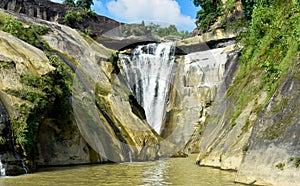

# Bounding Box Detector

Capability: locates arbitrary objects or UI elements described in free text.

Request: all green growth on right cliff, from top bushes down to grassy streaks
[227,1,300,128]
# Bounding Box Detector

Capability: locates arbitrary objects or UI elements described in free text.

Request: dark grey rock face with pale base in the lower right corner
[236,73,300,185]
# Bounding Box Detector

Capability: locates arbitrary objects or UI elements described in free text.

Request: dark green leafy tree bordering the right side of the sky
[194,0,222,32]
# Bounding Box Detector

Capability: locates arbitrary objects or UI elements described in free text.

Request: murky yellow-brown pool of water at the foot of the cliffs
[0,155,238,186]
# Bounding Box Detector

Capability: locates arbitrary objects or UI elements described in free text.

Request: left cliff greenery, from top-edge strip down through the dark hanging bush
[0,14,72,163]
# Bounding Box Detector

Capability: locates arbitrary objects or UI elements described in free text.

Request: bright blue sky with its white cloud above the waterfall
[51,0,199,31]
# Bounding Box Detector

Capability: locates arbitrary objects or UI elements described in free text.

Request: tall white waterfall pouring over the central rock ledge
[119,43,175,134]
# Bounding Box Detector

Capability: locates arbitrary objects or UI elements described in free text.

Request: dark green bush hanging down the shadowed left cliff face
[7,55,72,158]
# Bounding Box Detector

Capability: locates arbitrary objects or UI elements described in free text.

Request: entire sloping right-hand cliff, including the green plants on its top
[197,2,300,185]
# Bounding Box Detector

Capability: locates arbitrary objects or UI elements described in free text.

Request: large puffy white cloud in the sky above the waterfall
[106,0,195,30]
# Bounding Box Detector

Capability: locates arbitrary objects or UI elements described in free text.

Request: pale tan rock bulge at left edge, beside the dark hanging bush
[0,31,54,175]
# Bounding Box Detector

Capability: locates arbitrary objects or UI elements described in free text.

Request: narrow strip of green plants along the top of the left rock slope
[0,15,50,47]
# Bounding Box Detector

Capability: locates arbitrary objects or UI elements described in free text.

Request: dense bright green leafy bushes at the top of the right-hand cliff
[241,3,300,91]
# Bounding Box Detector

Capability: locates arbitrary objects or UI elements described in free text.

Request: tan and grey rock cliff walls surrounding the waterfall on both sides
[0,0,300,185]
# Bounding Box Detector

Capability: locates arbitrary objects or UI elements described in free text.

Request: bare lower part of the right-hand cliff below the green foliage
[193,29,300,185]
